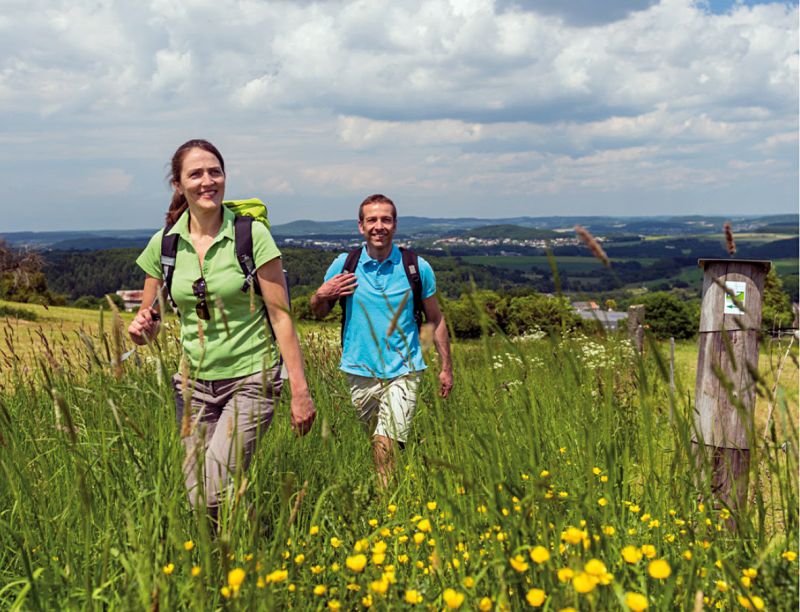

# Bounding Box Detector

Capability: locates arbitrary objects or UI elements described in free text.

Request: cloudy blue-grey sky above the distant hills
[0,0,799,232]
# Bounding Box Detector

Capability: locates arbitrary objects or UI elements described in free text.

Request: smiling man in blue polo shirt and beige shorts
[311,194,453,486]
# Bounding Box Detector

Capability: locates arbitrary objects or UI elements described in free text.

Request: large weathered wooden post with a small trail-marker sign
[692,259,771,510]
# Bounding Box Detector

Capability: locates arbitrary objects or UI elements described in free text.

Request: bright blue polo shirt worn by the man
[325,245,436,378]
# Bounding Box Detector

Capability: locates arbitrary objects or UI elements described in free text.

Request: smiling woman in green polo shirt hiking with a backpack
[128,140,316,520]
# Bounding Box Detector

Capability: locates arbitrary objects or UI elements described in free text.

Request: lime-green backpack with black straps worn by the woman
[161,198,289,316]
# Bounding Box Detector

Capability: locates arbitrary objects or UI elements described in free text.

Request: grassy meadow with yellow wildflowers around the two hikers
[0,307,799,610]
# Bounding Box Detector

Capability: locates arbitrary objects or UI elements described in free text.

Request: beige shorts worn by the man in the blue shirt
[347,372,422,442]
